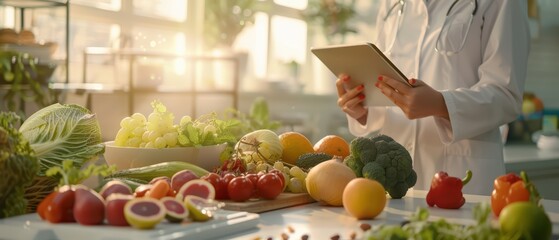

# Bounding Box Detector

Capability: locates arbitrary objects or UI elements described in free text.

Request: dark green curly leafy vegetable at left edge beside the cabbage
[0,112,39,218]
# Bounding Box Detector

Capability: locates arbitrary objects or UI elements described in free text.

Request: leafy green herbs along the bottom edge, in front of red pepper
[364,203,505,240]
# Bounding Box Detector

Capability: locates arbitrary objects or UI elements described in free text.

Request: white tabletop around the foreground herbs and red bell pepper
[227,190,559,240]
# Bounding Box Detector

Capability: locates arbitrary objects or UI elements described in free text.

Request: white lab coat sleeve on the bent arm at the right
[435,0,530,143]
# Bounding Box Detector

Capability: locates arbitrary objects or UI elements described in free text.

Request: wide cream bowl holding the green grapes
[103,141,227,171]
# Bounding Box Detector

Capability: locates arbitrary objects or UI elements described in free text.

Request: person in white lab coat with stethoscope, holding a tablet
[336,0,530,195]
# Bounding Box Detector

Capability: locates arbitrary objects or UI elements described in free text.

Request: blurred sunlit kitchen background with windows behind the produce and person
[0,0,559,238]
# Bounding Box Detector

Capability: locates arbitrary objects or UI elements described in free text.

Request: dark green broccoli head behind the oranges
[348,135,417,198]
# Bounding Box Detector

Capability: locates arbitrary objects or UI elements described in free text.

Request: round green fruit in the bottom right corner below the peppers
[499,202,552,239]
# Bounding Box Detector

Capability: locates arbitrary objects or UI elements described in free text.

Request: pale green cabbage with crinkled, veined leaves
[19,103,105,176]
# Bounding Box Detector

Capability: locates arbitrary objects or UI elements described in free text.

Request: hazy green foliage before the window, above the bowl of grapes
[204,0,258,49]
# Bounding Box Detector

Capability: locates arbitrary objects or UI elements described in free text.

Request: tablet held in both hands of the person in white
[311,43,411,106]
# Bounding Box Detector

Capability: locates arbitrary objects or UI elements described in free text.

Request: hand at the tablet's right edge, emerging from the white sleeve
[375,76,449,119]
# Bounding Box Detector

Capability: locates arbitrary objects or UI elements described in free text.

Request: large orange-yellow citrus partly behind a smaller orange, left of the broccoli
[306,158,356,206]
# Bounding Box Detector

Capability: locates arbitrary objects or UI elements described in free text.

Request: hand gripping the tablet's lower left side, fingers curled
[336,75,368,124]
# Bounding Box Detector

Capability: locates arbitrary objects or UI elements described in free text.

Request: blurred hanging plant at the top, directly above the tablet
[303,0,357,44]
